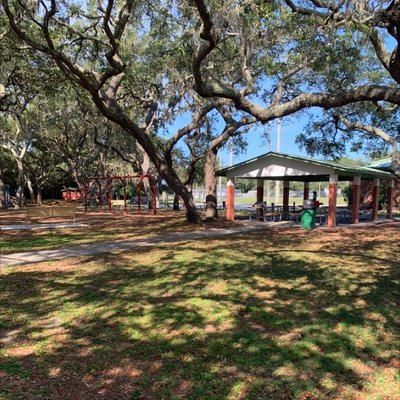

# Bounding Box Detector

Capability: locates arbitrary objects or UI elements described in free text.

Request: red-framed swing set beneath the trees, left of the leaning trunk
[85,174,157,214]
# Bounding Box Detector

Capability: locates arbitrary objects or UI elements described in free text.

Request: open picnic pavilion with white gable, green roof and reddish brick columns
[216,151,397,228]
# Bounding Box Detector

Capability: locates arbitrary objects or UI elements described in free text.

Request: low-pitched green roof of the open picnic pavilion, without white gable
[216,151,394,181]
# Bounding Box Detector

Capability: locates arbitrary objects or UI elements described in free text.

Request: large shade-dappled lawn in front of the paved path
[0,223,400,400]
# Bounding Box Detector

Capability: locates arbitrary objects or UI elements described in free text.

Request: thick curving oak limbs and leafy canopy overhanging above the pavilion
[193,0,400,175]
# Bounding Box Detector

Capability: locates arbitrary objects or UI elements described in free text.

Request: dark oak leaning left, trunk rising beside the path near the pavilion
[2,0,212,222]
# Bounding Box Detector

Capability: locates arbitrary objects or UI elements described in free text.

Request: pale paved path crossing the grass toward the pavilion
[0,221,290,268]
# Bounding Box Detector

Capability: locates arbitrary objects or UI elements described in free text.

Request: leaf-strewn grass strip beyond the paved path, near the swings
[0,210,230,254]
